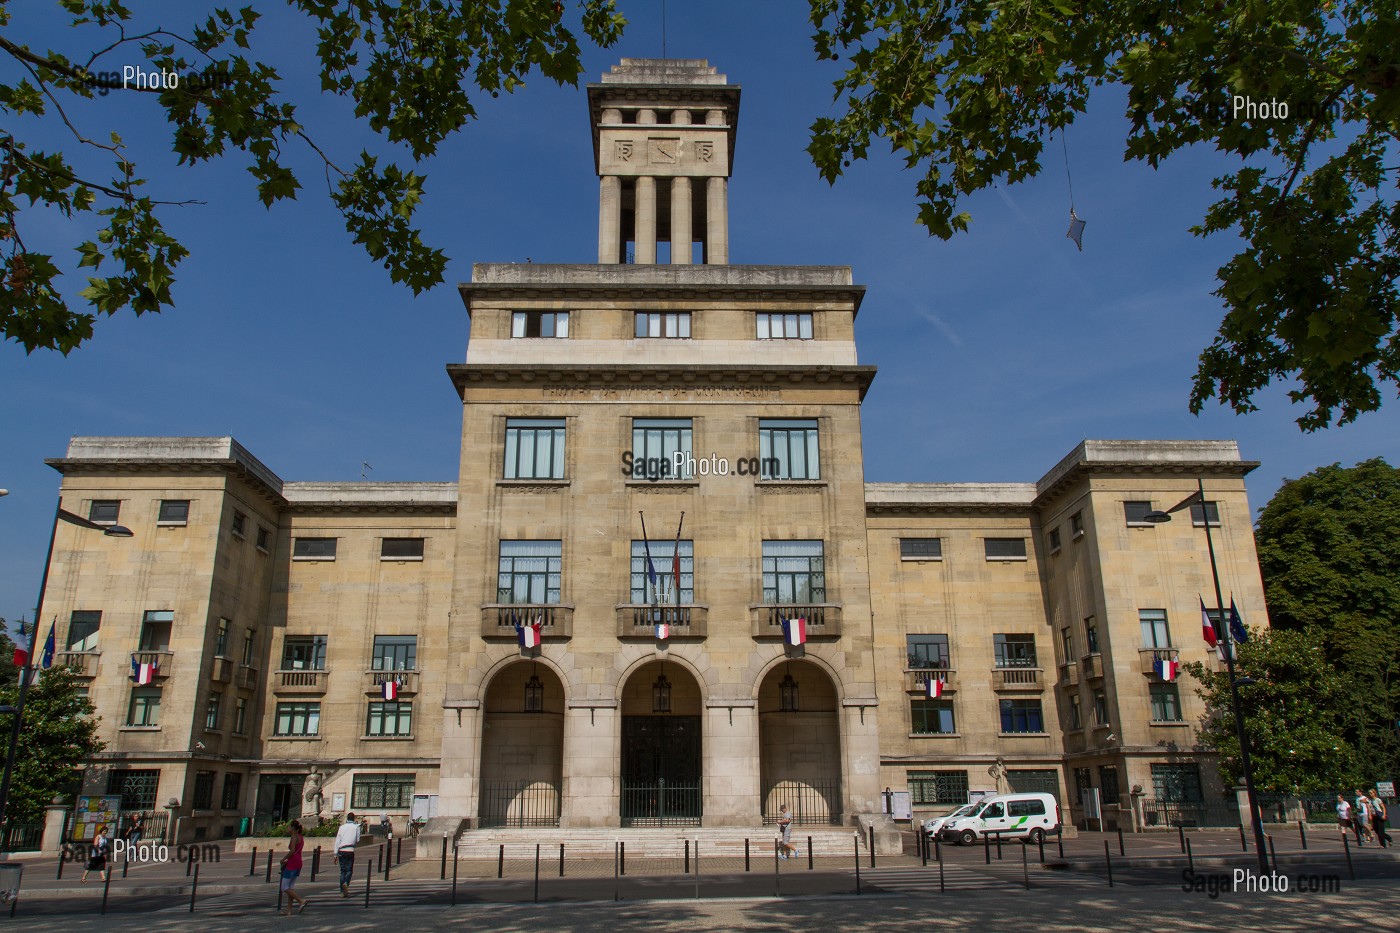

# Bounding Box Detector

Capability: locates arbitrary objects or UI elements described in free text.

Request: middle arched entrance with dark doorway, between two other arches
[619,661,703,827]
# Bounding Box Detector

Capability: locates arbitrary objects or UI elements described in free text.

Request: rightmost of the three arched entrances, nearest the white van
[759,660,841,825]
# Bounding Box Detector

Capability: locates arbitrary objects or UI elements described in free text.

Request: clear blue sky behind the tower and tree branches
[0,0,1400,619]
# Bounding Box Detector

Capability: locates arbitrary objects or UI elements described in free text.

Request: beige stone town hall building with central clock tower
[35,60,1264,839]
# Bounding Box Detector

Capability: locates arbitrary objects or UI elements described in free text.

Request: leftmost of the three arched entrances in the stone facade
[479,660,564,827]
